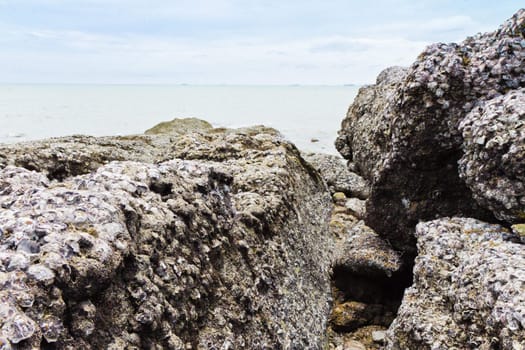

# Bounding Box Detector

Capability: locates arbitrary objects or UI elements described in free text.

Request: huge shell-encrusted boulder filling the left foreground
[0,128,333,349]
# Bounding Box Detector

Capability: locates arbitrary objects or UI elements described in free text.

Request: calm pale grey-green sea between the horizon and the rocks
[0,85,358,153]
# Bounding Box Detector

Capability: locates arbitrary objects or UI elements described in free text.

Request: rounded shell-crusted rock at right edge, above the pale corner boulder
[459,89,525,223]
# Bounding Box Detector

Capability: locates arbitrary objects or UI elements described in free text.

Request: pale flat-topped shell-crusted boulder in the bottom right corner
[386,218,525,349]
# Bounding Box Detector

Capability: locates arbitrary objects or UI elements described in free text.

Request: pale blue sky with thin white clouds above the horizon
[0,0,523,85]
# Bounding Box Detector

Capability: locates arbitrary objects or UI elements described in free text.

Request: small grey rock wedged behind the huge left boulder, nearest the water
[302,153,370,199]
